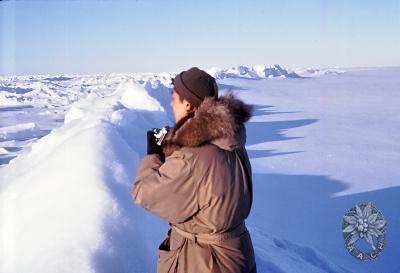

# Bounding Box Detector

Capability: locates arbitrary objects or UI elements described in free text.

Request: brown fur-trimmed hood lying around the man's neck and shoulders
[163,93,253,155]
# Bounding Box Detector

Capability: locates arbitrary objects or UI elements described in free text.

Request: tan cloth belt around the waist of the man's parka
[172,222,247,244]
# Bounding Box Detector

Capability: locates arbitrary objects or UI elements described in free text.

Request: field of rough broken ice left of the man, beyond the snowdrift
[0,72,176,108]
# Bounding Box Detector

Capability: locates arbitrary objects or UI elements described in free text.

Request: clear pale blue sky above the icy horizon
[0,0,400,75]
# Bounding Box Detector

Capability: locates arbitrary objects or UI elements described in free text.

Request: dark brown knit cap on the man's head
[172,67,218,107]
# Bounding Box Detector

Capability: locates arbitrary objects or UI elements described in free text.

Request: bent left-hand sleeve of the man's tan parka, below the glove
[132,151,198,223]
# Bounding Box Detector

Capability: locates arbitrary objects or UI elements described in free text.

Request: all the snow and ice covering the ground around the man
[0,66,400,273]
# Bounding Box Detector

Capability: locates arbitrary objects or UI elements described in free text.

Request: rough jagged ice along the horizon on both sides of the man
[0,64,344,108]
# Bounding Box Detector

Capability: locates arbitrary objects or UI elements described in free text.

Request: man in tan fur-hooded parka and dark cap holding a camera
[132,67,256,273]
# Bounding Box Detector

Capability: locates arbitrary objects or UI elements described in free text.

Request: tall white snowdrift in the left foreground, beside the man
[0,82,167,272]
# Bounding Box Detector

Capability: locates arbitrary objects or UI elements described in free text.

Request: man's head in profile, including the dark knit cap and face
[171,67,218,121]
